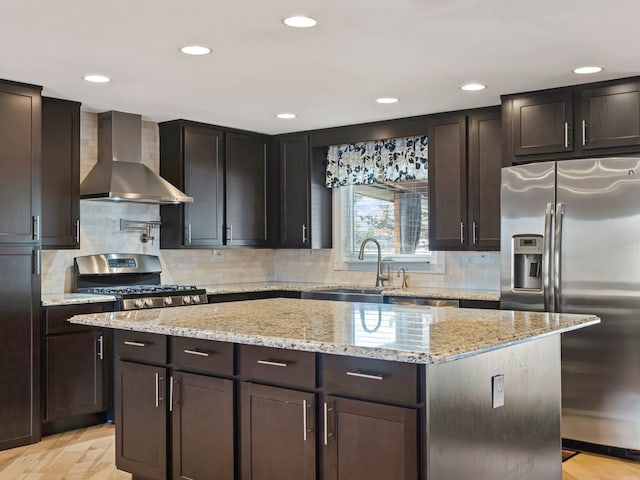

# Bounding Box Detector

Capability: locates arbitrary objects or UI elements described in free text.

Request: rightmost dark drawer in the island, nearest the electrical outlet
[322,355,418,404]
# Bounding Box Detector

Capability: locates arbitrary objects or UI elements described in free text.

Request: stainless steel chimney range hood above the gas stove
[80,111,193,204]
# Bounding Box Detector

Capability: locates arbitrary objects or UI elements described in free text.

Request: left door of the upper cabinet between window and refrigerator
[429,115,467,250]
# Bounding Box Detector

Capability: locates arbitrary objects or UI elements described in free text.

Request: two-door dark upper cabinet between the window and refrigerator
[429,107,502,250]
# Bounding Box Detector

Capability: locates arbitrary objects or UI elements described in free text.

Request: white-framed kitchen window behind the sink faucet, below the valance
[336,180,437,269]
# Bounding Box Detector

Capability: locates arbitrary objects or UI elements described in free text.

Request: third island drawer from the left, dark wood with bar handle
[239,345,316,388]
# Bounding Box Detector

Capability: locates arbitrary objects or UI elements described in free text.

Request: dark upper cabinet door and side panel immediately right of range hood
[159,121,224,248]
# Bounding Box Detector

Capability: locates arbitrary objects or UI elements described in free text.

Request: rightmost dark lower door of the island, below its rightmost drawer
[322,396,419,480]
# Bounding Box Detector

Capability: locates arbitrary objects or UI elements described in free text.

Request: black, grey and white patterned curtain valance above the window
[326,136,428,188]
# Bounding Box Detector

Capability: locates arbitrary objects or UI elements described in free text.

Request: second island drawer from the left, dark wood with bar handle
[171,337,233,375]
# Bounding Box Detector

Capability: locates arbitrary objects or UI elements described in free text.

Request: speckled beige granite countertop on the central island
[70,298,600,363]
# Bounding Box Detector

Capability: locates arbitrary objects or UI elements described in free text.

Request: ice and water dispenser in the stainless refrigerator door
[512,235,542,290]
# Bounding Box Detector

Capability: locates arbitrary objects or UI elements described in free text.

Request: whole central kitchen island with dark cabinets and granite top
[70,299,599,480]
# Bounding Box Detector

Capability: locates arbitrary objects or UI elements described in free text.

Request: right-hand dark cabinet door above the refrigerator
[580,82,640,150]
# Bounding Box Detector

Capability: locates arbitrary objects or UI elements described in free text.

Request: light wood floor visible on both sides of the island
[0,425,640,480]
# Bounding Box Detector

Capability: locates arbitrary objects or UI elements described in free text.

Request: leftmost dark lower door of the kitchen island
[115,360,167,480]
